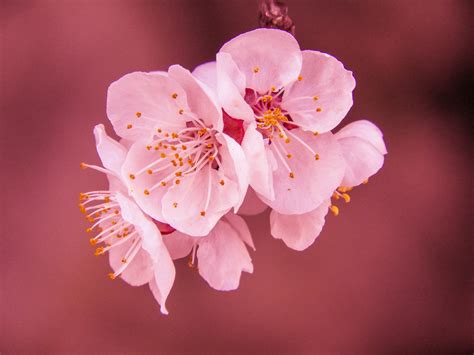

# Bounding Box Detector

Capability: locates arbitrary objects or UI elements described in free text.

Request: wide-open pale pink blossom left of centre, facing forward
[107,65,249,236]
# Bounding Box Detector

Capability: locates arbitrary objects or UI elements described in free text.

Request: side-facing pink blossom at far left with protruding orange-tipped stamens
[79,125,175,314]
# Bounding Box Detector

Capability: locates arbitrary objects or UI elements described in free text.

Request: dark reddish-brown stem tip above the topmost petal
[258,0,295,36]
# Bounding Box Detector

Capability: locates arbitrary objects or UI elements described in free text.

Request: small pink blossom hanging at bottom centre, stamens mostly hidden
[164,212,255,291]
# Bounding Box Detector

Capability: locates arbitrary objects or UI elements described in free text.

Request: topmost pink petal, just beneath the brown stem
[220,29,302,94]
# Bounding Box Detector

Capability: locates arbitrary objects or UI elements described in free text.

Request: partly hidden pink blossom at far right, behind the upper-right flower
[270,121,387,250]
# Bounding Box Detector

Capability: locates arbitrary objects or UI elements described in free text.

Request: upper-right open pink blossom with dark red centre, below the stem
[194,29,355,214]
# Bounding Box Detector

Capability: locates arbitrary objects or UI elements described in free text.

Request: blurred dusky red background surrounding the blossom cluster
[0,0,473,354]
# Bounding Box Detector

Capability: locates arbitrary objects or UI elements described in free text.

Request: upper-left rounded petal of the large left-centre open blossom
[107,72,189,141]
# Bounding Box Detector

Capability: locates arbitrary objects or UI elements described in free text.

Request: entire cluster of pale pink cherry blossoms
[79,29,387,314]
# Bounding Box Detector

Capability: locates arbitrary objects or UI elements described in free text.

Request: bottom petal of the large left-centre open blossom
[162,167,239,237]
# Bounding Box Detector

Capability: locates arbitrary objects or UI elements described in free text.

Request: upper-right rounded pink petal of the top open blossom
[282,51,355,133]
